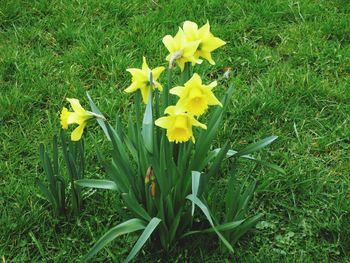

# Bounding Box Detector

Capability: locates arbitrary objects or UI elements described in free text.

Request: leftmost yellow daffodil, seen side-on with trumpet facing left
[60,99,94,141]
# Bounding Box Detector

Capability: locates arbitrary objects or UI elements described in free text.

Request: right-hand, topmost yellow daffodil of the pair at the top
[183,21,226,65]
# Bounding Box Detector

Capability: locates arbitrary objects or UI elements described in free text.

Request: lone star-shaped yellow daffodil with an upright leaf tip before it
[124,57,165,103]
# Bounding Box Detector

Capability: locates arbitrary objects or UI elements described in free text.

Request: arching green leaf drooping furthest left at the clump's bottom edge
[84,218,146,261]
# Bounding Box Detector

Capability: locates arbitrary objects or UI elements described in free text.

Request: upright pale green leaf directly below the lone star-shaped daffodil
[142,87,153,153]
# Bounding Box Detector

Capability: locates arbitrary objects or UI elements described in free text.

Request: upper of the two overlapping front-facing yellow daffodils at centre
[170,73,222,116]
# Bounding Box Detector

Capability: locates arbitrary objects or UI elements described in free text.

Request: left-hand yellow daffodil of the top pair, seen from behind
[163,28,200,71]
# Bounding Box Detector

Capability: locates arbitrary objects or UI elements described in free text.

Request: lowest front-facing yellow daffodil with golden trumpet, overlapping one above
[155,106,207,143]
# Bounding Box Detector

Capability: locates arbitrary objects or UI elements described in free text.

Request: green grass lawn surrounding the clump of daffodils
[0,0,350,262]
